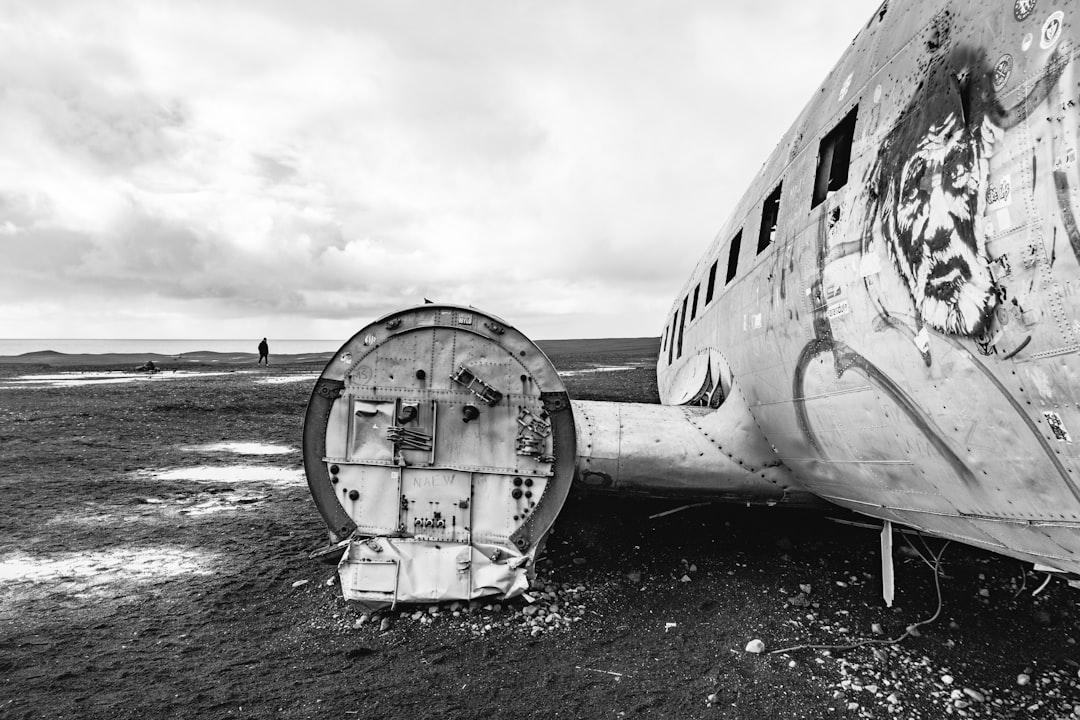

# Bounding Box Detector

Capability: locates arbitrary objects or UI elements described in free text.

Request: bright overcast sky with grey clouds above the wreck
[0,0,879,340]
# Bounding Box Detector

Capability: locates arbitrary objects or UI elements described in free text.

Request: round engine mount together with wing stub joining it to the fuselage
[303,304,809,604]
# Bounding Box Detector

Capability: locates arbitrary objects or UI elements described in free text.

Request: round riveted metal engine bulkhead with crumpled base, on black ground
[303,304,576,603]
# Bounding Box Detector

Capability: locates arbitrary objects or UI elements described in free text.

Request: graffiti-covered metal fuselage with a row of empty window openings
[657,0,1080,572]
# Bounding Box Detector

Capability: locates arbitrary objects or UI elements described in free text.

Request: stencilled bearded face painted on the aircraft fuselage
[881,113,995,336]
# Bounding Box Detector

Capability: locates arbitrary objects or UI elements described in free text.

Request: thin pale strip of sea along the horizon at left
[0,338,349,356]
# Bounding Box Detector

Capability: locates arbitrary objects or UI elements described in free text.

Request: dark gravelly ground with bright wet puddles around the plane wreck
[0,340,1080,720]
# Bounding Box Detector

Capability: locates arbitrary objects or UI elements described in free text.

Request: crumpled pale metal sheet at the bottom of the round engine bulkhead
[338,538,536,607]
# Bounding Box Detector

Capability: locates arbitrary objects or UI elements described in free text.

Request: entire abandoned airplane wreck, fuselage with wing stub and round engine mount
[303,0,1080,604]
